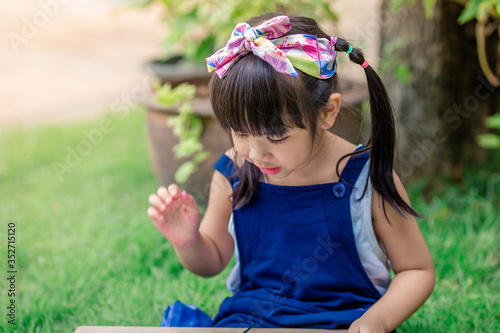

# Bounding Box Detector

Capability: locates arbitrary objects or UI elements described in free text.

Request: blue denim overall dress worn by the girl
[162,148,381,329]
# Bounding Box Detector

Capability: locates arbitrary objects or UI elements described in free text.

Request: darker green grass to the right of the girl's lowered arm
[399,167,500,332]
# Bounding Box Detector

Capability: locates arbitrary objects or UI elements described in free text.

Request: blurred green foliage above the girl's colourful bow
[135,0,337,65]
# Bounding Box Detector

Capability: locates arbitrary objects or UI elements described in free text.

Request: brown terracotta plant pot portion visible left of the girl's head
[143,63,231,204]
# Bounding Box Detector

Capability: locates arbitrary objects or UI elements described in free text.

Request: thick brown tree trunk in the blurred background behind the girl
[381,0,500,179]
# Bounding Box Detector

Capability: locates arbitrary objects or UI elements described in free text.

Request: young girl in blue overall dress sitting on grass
[148,13,435,332]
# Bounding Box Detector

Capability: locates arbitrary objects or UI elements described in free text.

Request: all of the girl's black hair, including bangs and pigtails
[209,13,420,217]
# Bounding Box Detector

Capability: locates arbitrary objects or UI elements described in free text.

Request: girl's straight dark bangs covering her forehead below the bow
[210,54,308,137]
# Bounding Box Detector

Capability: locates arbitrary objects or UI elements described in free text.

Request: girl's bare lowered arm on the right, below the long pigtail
[348,173,435,333]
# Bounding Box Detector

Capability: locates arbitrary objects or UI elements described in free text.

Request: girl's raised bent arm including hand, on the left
[148,167,234,277]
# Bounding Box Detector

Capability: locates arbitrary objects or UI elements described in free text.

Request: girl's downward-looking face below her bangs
[231,128,313,180]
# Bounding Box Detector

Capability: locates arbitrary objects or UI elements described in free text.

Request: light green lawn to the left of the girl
[0,111,228,332]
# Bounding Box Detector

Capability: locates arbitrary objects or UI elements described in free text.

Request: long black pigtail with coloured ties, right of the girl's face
[335,37,422,217]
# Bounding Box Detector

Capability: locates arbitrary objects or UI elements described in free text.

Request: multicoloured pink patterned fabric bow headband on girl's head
[206,16,337,79]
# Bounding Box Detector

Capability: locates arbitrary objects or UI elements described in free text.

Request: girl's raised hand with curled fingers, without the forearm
[148,184,200,246]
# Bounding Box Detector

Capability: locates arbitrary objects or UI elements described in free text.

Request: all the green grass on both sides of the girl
[0,110,500,332]
